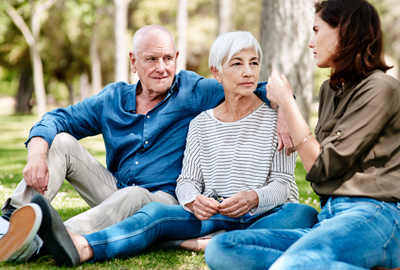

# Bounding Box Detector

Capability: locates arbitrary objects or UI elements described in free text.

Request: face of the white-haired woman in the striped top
[211,49,260,96]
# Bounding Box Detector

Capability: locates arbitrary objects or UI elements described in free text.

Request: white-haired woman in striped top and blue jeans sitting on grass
[0,32,317,266]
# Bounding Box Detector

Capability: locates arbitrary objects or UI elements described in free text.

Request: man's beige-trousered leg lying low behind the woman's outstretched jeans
[64,186,178,234]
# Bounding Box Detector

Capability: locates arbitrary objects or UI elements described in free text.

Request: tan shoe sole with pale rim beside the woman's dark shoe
[0,204,42,262]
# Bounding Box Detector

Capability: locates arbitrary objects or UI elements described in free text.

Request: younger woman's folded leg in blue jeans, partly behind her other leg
[205,229,310,270]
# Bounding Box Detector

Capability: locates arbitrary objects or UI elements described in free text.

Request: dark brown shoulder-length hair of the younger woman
[314,0,392,90]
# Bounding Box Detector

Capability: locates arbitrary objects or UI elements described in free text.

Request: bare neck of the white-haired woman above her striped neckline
[214,92,262,122]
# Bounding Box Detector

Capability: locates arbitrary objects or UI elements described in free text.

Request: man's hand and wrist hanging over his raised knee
[23,137,50,195]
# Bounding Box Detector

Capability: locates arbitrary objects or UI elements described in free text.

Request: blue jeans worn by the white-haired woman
[84,202,318,261]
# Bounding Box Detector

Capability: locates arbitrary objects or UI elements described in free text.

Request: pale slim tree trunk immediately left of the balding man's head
[114,0,131,82]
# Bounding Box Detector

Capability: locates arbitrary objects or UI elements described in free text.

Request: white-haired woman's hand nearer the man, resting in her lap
[185,195,219,220]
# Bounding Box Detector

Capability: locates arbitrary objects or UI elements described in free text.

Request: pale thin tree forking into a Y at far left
[7,0,58,117]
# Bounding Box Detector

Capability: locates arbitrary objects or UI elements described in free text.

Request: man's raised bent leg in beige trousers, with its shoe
[2,133,118,213]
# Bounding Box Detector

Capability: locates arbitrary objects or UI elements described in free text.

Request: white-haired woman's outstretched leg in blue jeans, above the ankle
[84,202,223,261]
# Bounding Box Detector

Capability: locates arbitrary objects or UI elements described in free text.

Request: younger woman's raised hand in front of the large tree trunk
[267,69,293,106]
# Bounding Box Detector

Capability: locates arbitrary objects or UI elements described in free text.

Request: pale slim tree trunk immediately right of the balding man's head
[176,0,188,72]
